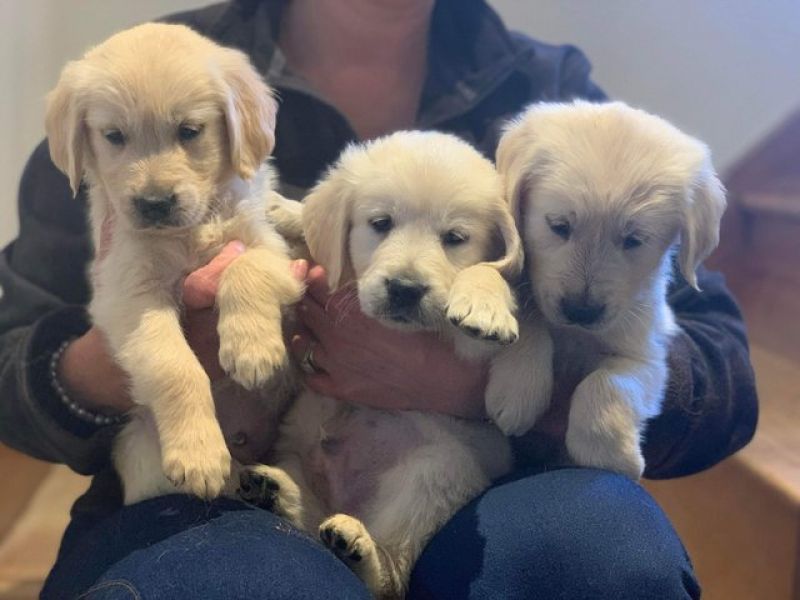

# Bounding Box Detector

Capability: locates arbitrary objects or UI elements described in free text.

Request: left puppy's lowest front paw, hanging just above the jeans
[161,420,231,500]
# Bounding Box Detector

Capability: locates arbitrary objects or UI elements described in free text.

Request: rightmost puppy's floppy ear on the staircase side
[678,155,726,290]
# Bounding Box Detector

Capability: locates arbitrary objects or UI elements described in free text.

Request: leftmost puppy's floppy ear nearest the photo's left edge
[45,62,88,196]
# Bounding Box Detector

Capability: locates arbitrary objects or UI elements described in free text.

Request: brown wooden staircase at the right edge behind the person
[646,112,800,600]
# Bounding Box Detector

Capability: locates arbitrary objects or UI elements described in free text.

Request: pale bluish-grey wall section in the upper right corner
[493,0,800,170]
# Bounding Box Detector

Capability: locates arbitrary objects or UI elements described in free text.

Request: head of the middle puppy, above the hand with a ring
[303,131,522,329]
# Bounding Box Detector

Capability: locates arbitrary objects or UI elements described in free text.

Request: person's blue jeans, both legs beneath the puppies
[42,469,700,600]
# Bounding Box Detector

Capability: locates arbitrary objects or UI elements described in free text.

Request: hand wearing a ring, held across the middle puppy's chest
[291,266,488,419]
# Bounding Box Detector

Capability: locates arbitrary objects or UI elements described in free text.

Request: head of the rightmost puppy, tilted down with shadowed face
[504,102,725,330]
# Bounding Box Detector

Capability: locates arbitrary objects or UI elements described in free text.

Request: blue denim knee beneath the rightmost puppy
[411,469,700,600]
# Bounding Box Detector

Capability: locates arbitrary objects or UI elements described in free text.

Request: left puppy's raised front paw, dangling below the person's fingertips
[218,314,287,390]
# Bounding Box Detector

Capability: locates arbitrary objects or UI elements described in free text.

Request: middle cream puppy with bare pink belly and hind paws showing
[241,132,536,597]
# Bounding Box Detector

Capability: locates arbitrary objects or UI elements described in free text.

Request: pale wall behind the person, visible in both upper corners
[0,0,800,245]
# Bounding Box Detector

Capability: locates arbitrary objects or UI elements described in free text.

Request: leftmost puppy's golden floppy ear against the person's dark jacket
[221,49,278,179]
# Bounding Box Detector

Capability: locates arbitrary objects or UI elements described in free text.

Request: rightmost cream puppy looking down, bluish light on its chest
[497,102,725,478]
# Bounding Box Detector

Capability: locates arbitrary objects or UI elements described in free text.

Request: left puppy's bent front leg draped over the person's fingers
[217,247,302,389]
